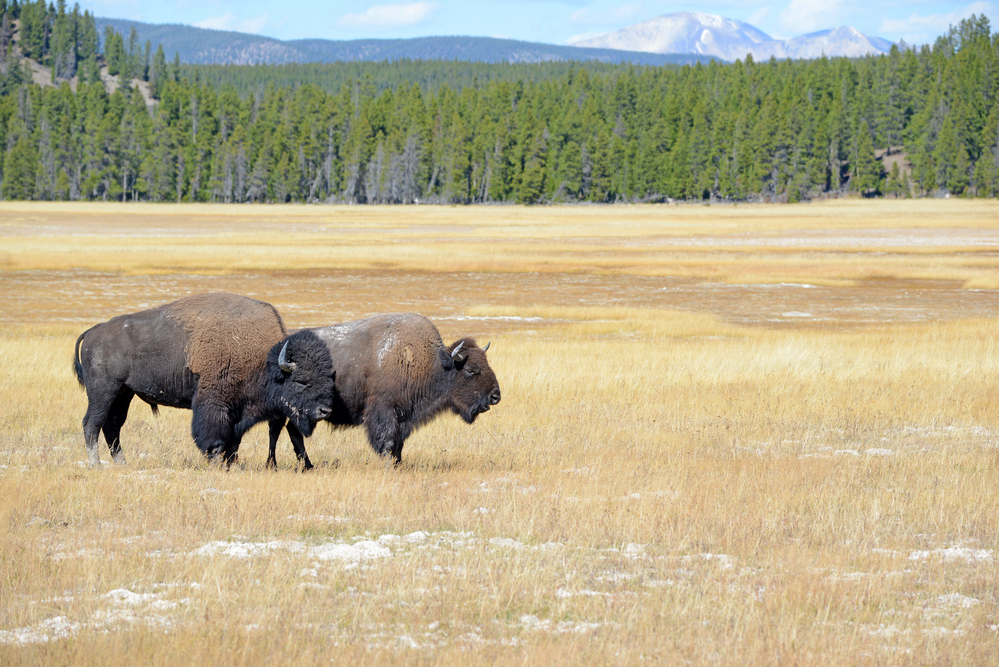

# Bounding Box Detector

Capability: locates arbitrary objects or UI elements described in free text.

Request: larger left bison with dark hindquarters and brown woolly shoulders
[73,294,335,468]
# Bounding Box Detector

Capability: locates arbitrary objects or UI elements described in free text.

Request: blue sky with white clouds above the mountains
[80,0,999,44]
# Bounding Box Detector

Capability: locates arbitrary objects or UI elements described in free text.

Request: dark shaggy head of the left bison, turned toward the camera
[267,331,336,436]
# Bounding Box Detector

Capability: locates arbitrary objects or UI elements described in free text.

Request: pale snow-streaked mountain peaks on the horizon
[576,12,891,60]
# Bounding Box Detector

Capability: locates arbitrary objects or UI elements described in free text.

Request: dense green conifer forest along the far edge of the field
[0,16,999,203]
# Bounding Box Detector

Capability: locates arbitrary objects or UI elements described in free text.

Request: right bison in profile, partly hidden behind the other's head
[267,313,500,466]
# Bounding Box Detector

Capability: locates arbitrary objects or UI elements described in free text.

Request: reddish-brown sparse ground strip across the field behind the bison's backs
[0,270,999,335]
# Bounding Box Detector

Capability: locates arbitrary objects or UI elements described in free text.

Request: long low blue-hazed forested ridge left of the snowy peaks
[95,18,715,65]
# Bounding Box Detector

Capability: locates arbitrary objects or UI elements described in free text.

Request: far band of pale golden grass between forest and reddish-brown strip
[0,200,999,288]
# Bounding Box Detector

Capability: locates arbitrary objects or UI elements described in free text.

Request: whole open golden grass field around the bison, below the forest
[0,200,999,665]
